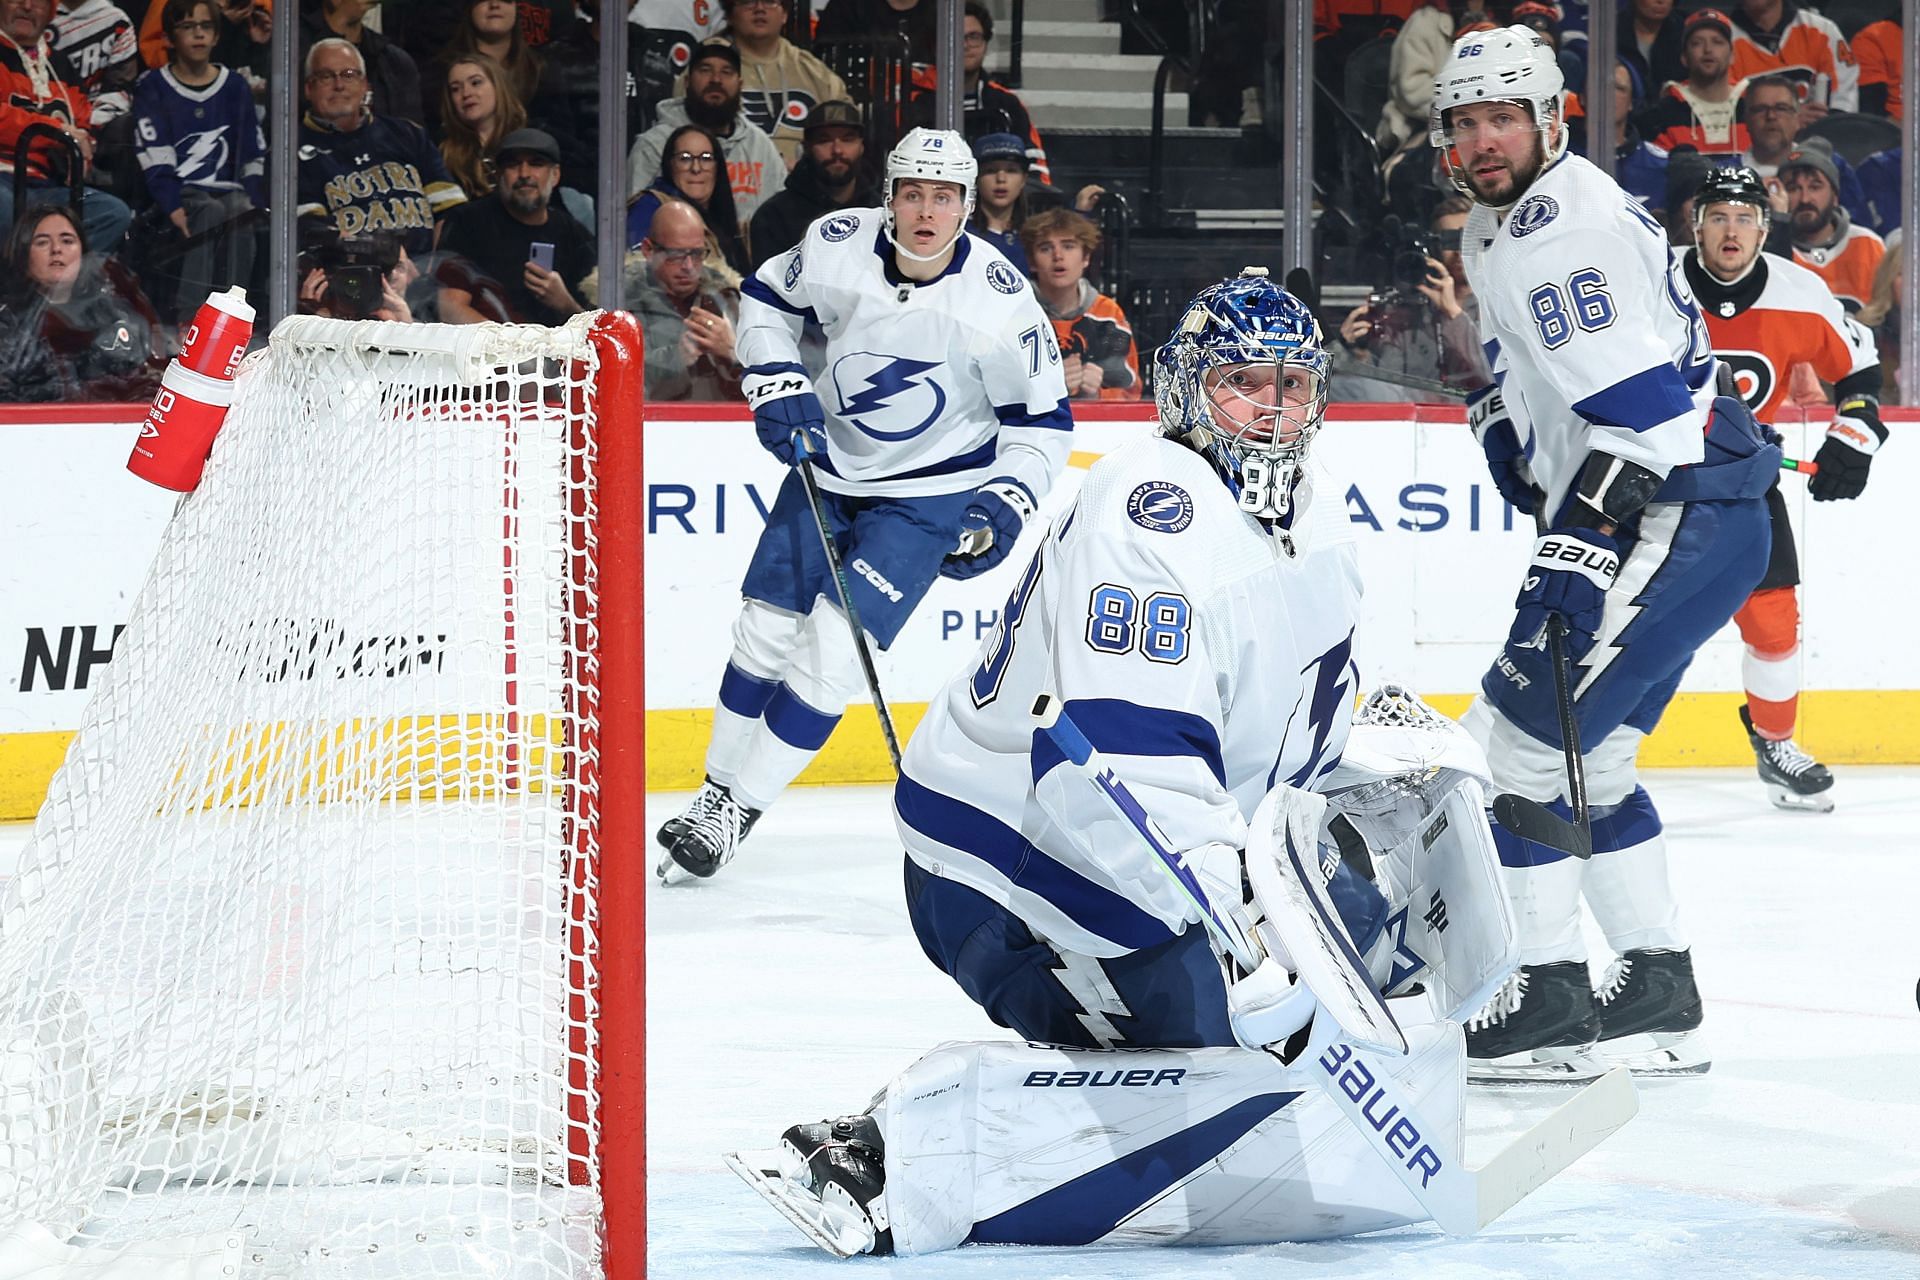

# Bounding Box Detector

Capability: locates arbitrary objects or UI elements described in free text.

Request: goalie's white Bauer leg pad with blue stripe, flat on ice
[879,1023,1465,1253]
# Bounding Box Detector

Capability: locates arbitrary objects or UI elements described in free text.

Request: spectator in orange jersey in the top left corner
[0,0,132,253]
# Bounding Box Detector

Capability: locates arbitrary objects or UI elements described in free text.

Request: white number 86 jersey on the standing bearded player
[1461,155,1715,512]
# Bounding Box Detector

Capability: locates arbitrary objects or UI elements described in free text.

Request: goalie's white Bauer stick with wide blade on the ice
[1033,693,1640,1236]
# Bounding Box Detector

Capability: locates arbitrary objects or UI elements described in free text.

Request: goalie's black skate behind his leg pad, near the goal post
[722,1115,893,1257]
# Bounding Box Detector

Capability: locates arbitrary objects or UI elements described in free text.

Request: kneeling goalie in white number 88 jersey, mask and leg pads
[728,269,1624,1255]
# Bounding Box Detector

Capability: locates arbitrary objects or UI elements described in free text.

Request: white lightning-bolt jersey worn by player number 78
[737,209,1073,501]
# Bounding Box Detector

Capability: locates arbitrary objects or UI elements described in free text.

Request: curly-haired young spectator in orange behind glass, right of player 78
[1020,209,1140,399]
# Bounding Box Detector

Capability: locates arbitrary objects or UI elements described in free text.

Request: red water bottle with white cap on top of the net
[127,286,253,493]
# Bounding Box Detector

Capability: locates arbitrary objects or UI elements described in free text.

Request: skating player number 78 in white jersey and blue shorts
[659,129,1073,877]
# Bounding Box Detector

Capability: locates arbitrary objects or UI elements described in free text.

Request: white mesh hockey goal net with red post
[0,315,645,1280]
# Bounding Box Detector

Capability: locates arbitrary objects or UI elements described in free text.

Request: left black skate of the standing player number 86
[1467,960,1607,1084]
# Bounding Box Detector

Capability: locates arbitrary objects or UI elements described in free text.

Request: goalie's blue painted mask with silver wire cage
[1154,267,1331,520]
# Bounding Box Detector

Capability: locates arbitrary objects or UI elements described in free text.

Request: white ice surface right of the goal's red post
[645,768,1920,1280]
